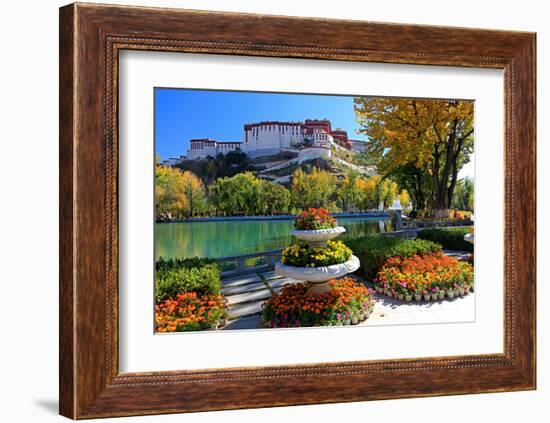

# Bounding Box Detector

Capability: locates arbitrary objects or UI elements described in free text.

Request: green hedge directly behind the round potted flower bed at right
[347,236,442,280]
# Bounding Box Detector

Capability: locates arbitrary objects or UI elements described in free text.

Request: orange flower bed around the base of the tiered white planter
[262,278,374,327]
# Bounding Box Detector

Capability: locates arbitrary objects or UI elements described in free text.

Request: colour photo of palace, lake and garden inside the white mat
[153,87,476,334]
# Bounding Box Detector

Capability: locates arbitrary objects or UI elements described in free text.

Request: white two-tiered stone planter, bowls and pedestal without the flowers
[275,222,360,294]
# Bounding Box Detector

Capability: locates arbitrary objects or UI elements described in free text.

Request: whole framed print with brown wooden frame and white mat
[60,4,536,418]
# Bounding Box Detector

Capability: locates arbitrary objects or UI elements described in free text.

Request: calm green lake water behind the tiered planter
[155,217,391,259]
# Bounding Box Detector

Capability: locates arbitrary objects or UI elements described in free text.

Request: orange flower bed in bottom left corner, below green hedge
[155,292,227,332]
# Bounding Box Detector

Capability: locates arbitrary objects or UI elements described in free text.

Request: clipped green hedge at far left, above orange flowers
[155,257,221,303]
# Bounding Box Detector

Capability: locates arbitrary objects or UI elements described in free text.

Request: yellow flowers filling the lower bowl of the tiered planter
[282,241,352,267]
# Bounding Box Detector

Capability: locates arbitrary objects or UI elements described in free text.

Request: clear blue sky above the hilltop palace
[155,88,365,159]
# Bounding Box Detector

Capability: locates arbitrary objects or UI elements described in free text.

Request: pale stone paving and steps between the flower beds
[222,251,475,330]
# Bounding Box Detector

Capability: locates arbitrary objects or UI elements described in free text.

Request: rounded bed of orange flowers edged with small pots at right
[374,253,474,301]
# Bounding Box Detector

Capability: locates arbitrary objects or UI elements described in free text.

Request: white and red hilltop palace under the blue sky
[187,119,362,160]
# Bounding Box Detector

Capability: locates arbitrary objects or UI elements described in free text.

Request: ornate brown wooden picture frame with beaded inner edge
[59,4,536,419]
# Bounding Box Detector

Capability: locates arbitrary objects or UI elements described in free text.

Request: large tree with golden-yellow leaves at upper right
[354,97,474,215]
